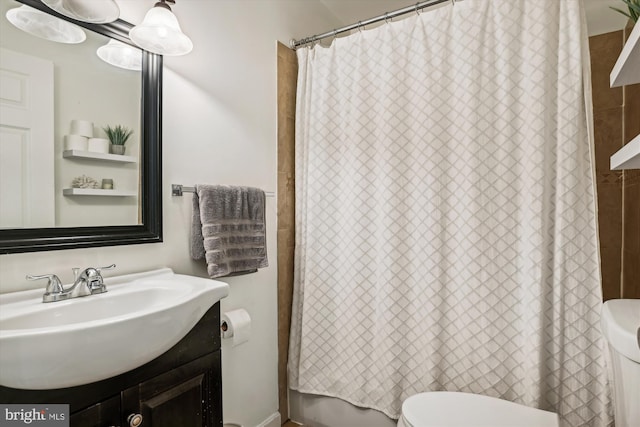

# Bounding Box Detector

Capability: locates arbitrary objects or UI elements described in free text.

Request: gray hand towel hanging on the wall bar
[191,185,269,279]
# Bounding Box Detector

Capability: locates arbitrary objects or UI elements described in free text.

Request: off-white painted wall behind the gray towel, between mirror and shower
[0,0,337,427]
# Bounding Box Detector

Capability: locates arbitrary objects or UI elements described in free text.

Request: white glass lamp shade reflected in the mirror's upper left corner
[6,5,87,44]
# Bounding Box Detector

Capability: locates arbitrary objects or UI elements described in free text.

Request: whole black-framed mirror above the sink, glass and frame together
[0,0,162,254]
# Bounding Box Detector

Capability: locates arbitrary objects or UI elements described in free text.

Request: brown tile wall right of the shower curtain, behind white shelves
[589,24,640,300]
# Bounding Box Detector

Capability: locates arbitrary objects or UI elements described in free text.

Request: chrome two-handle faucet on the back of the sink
[27,264,116,302]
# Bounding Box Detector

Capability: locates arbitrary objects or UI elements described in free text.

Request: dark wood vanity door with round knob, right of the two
[122,351,222,427]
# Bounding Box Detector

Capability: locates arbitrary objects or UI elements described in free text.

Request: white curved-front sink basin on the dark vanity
[0,268,229,390]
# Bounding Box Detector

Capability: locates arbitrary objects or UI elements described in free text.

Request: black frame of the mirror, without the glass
[0,0,162,254]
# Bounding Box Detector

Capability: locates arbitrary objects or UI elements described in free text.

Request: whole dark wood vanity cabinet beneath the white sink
[0,302,222,427]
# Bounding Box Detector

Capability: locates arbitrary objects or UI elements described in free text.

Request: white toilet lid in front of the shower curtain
[402,391,559,427]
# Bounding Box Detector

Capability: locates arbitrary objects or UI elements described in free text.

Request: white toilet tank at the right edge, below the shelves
[602,299,640,427]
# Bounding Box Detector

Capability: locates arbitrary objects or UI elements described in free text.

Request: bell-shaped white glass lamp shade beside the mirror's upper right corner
[129,0,193,56]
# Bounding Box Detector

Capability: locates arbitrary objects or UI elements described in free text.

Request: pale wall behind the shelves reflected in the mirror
[52,31,141,227]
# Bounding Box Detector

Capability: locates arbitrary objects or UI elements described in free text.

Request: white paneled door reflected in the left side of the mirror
[0,48,55,228]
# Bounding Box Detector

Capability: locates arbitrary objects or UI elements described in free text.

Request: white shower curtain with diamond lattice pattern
[289,0,612,426]
